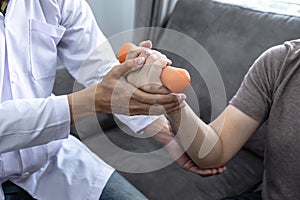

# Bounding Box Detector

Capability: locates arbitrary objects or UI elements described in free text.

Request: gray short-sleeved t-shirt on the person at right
[230,40,300,200]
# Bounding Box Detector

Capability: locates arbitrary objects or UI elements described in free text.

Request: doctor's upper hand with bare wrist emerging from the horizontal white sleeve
[68,56,185,123]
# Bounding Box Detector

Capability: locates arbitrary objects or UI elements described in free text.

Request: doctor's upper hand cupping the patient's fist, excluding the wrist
[96,57,185,115]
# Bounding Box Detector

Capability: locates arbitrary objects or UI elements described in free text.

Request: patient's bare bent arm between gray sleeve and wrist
[168,105,260,168]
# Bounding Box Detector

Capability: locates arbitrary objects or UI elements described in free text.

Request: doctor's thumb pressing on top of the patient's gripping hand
[114,57,145,76]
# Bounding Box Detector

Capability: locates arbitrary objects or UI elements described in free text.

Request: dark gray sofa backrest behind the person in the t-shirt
[158,0,300,156]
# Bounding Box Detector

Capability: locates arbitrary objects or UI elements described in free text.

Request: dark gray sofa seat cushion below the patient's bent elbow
[84,126,263,200]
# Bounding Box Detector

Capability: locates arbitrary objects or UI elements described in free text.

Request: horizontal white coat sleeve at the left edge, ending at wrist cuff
[0,96,70,154]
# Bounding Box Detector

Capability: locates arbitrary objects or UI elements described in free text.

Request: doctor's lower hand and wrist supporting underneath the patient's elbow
[143,117,226,176]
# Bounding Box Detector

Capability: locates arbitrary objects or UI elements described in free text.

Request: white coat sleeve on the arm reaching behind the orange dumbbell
[58,0,158,132]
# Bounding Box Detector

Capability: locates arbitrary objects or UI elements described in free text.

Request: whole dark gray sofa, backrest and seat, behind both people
[54,0,300,200]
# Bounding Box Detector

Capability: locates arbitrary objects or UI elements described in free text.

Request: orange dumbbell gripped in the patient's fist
[118,43,191,93]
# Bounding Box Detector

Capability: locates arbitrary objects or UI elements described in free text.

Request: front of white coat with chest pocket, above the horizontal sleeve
[0,0,65,99]
